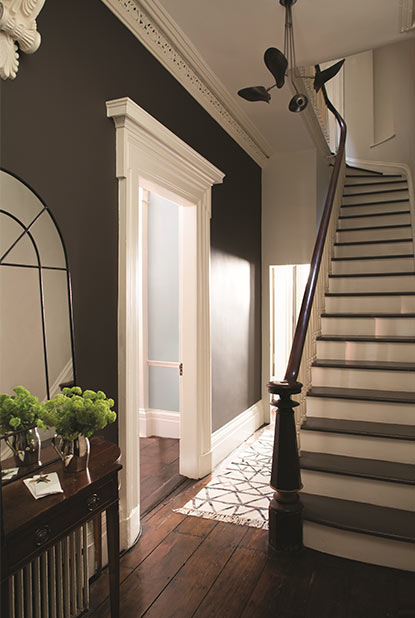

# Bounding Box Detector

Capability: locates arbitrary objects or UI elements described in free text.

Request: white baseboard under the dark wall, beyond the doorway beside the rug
[212,400,264,468]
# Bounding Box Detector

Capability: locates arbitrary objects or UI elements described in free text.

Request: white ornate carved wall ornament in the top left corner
[0,0,45,79]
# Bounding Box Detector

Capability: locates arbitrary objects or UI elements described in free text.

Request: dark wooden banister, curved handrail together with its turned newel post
[267,71,346,551]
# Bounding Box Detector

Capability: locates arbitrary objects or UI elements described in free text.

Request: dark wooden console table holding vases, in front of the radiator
[1,437,122,618]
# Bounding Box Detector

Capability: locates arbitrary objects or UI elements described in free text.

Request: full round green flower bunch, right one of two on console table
[40,386,117,440]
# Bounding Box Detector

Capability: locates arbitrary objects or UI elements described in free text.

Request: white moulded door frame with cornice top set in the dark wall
[106,97,224,548]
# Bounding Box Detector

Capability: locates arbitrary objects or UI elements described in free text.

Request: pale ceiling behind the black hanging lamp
[155,0,413,151]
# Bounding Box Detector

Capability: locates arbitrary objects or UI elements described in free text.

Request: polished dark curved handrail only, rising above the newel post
[284,79,347,384]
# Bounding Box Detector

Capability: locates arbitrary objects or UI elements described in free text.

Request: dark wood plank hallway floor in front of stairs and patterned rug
[90,454,415,618]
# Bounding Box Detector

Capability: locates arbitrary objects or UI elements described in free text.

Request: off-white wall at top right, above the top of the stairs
[344,38,415,174]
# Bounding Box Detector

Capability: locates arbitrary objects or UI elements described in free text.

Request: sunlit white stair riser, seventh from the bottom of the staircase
[321,318,415,337]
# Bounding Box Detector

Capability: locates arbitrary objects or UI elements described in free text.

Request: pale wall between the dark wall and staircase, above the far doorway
[262,148,329,415]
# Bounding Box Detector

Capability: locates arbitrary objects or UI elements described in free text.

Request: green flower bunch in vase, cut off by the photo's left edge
[0,386,44,433]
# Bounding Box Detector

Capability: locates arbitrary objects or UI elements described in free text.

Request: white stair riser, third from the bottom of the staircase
[300,429,415,464]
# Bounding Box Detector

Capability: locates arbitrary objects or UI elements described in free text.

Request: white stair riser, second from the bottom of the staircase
[301,469,415,511]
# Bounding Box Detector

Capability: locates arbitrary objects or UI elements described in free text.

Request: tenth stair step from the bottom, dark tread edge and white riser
[332,254,415,275]
